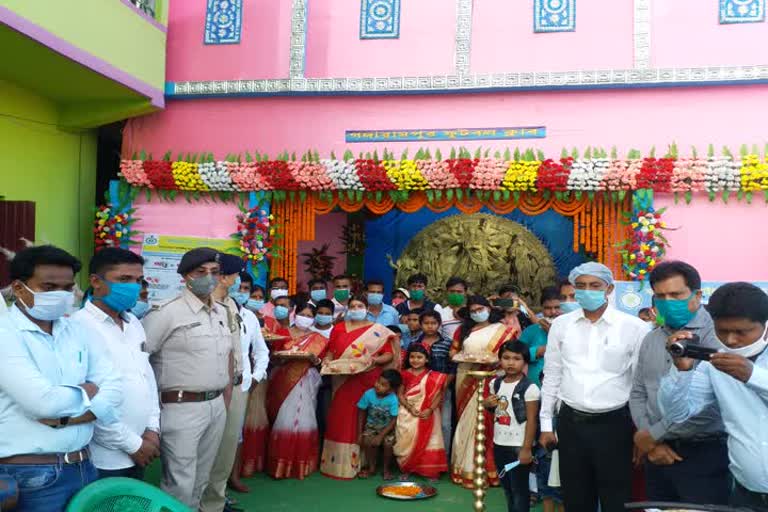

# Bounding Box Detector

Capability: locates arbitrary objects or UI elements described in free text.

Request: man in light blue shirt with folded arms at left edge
[0,246,122,512]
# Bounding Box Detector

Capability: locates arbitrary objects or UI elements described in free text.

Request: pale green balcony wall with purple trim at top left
[0,0,165,91]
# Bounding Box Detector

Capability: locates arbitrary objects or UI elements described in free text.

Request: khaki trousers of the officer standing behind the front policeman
[200,386,248,512]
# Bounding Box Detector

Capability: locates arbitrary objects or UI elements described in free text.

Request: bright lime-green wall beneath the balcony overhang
[0,81,96,270]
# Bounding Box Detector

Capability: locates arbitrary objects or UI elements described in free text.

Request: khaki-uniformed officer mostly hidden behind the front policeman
[200,254,250,512]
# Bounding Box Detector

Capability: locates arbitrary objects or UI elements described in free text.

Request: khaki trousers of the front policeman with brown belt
[160,396,227,510]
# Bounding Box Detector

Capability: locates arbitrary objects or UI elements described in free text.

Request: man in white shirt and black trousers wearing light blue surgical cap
[540,262,650,512]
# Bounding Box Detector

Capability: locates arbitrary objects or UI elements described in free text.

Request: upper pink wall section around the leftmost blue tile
[166,0,291,82]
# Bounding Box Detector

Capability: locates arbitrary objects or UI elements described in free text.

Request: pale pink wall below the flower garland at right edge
[655,195,768,281]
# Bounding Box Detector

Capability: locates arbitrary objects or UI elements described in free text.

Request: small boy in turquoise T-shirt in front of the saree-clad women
[357,369,402,480]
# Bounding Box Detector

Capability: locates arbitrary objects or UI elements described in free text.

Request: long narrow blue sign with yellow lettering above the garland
[345,126,547,143]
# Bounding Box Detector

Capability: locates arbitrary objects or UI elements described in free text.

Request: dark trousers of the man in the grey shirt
[645,439,731,505]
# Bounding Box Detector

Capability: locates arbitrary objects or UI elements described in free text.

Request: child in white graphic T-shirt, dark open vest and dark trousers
[483,341,540,512]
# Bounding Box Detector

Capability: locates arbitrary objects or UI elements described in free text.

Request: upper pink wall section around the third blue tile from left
[471,0,634,73]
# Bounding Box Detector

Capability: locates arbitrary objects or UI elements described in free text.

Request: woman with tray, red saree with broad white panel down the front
[267,304,328,480]
